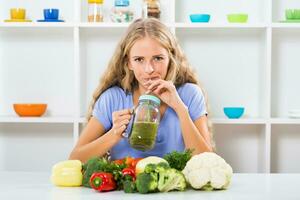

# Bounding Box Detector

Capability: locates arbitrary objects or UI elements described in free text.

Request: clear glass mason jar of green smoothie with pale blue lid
[129,95,160,151]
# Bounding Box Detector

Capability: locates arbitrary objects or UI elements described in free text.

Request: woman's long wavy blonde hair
[87,18,215,150]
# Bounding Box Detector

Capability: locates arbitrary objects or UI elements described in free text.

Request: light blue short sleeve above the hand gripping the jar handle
[92,89,113,131]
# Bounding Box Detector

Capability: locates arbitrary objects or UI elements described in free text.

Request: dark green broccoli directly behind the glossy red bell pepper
[82,157,126,189]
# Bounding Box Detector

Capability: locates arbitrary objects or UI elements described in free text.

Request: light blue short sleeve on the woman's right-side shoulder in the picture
[181,83,207,121]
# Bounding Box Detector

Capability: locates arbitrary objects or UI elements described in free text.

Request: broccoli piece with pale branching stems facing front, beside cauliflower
[158,168,186,192]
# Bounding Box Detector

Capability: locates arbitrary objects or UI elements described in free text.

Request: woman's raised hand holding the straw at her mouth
[144,79,184,110]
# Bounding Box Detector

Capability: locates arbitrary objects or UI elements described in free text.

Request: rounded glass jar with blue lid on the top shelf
[110,0,134,23]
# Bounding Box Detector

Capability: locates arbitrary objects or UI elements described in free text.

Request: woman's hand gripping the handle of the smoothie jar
[111,109,132,136]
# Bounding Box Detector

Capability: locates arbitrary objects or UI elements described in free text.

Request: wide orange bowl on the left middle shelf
[14,103,47,117]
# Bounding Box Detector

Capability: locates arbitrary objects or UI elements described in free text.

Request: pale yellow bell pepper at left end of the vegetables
[51,160,82,187]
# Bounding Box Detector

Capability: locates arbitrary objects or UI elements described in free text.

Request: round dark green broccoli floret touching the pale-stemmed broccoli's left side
[136,172,158,194]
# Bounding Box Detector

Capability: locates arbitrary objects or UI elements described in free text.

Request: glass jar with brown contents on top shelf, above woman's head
[143,0,161,19]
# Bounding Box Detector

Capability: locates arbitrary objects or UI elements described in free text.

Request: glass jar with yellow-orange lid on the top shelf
[88,0,103,22]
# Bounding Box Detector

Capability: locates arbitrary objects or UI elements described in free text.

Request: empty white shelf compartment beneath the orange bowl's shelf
[0,123,74,172]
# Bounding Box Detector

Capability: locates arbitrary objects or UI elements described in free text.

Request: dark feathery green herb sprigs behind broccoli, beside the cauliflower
[164,149,193,171]
